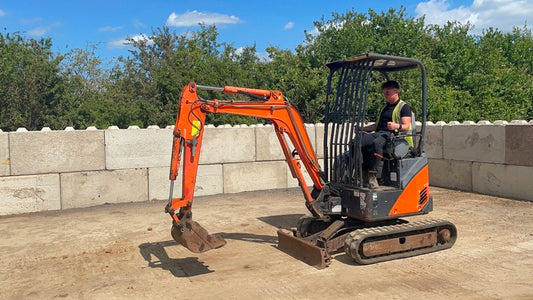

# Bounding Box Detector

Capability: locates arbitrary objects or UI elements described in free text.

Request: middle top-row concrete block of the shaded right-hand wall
[442,125,505,163]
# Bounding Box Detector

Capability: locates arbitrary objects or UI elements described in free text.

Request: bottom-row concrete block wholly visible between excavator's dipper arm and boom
[223,161,287,193]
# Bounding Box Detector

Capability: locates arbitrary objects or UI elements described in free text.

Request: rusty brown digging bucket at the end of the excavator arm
[171,219,226,253]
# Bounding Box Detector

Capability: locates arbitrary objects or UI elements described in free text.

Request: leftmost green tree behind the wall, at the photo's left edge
[0,33,63,130]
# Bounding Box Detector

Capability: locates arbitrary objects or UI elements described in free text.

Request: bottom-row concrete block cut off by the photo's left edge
[0,174,61,215]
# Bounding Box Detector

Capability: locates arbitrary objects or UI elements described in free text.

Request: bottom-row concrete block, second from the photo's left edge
[60,169,148,209]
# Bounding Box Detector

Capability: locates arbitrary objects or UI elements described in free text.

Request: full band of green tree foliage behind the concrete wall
[0,7,533,130]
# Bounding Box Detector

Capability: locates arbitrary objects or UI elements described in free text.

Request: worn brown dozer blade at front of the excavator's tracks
[278,229,331,269]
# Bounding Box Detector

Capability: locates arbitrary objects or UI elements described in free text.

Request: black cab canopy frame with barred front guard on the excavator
[324,53,427,186]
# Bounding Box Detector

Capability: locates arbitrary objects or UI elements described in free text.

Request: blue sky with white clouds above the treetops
[0,0,533,59]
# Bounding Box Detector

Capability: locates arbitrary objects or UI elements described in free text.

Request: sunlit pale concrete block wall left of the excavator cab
[0,125,323,215]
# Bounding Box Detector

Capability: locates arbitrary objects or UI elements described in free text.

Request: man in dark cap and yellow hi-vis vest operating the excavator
[361,80,412,188]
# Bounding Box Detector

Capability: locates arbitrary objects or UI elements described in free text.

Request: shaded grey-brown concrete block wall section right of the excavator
[425,121,533,201]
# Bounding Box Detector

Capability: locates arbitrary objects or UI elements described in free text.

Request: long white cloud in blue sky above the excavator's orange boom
[165,10,241,27]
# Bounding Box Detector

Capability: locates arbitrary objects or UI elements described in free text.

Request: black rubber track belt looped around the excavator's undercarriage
[344,220,457,265]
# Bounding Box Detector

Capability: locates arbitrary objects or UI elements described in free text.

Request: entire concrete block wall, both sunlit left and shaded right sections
[0,121,533,215]
